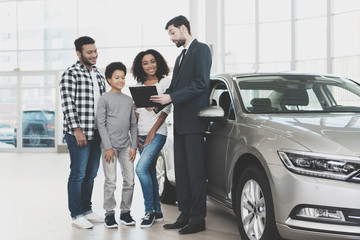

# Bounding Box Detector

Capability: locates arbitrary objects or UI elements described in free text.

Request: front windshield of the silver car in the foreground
[235,75,360,113]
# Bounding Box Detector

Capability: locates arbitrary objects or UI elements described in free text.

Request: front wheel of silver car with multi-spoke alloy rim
[235,166,281,240]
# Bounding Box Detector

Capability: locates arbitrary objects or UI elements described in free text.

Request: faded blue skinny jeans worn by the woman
[135,134,166,213]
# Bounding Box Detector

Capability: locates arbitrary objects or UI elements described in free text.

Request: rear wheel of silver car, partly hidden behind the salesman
[156,153,176,204]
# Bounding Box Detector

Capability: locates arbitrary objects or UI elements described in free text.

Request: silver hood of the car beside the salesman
[248,113,360,157]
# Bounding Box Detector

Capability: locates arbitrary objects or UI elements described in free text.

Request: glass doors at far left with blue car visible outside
[0,71,59,152]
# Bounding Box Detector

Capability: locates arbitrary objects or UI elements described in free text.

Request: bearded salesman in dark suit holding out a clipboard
[151,15,212,234]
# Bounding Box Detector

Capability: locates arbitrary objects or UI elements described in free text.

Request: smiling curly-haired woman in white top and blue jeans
[131,49,171,228]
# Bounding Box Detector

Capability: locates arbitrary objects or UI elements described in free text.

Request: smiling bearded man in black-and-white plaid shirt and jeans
[60,36,105,228]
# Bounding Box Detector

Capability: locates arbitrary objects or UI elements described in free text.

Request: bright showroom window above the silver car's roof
[223,0,360,82]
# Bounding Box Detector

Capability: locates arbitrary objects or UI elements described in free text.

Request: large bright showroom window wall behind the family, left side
[0,0,190,151]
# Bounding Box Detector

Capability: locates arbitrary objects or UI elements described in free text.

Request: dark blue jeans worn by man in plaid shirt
[65,131,101,218]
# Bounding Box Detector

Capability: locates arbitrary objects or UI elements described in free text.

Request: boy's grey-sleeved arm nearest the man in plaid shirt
[96,96,112,150]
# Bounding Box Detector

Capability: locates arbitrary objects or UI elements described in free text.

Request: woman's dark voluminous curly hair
[131,49,170,83]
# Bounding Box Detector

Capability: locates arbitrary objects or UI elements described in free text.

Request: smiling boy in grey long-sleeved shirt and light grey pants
[97,62,137,228]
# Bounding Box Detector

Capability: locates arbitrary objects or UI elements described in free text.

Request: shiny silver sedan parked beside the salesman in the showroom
[159,73,360,240]
